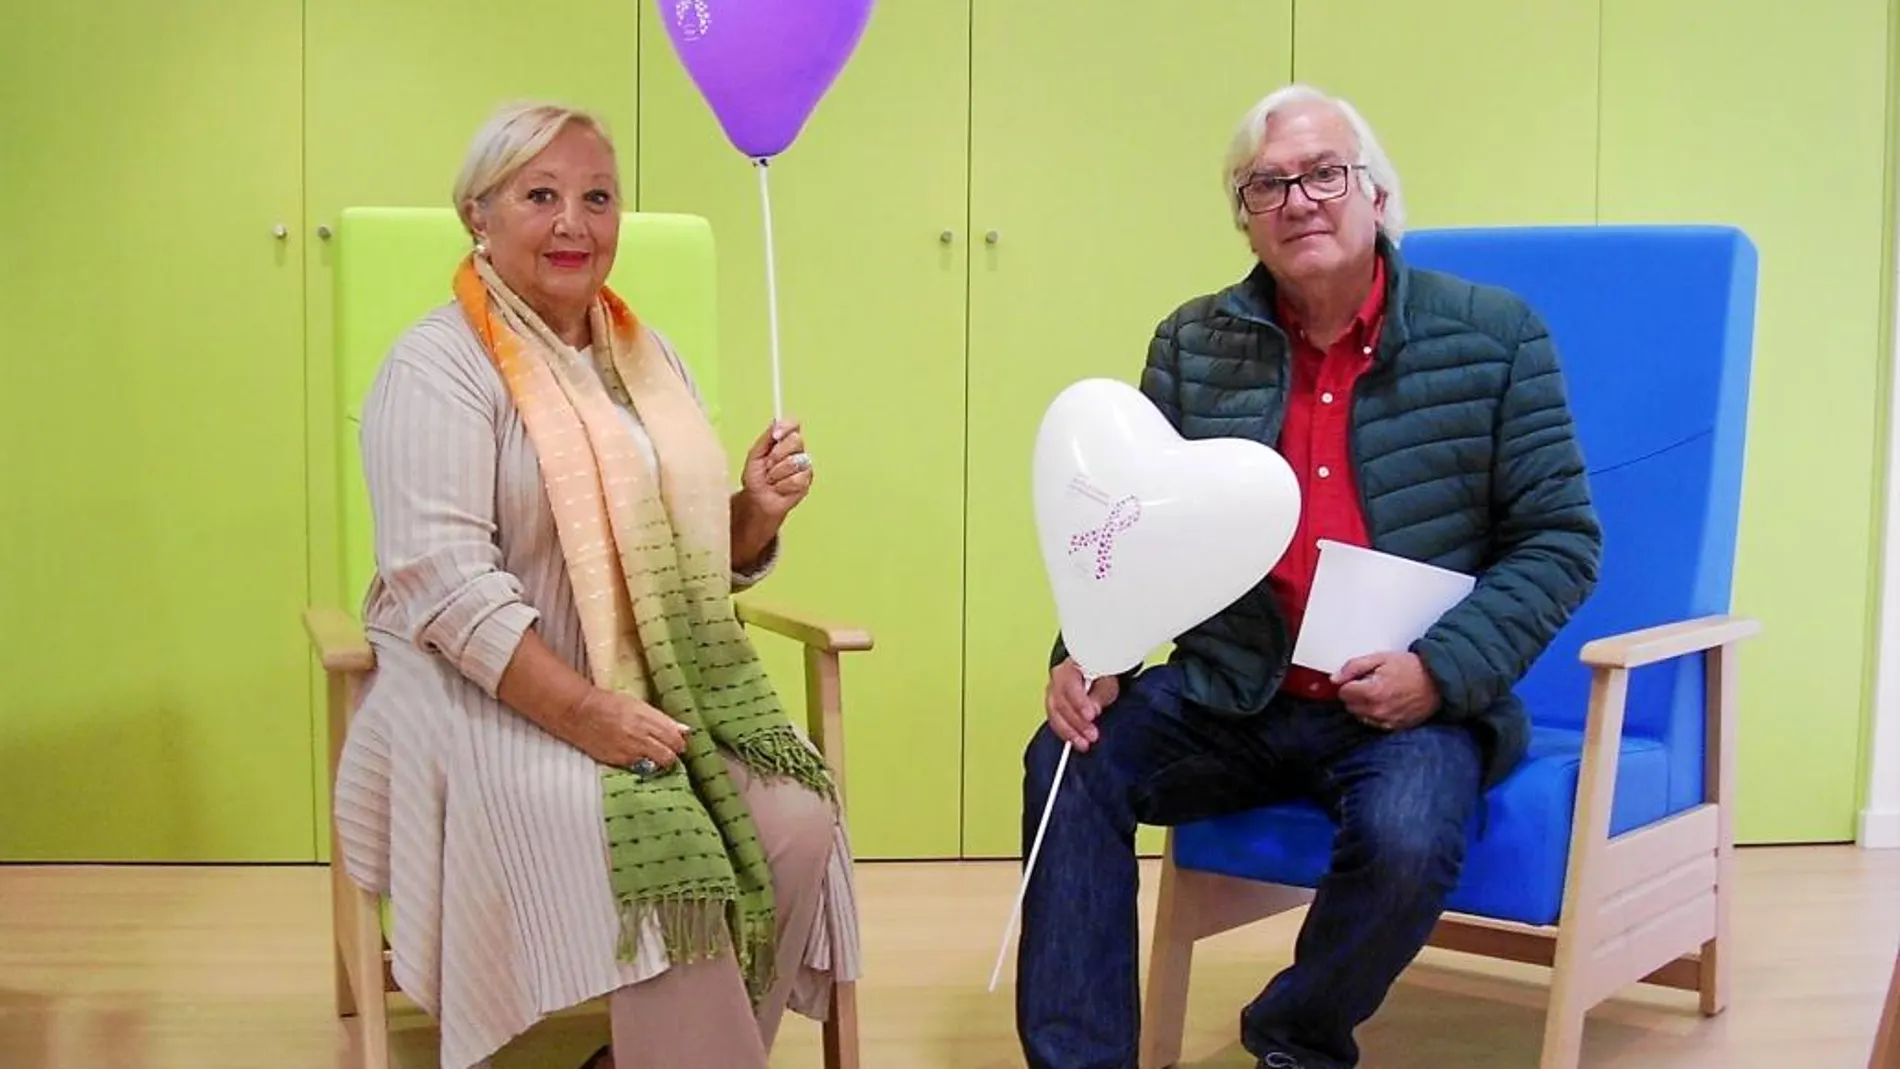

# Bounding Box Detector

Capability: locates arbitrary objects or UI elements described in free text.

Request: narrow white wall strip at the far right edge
[1856,135,1900,849]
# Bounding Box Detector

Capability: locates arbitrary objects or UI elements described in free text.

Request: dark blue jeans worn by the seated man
[1017,666,1482,1069]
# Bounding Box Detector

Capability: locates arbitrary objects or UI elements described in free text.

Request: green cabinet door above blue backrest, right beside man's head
[1294,0,1598,228]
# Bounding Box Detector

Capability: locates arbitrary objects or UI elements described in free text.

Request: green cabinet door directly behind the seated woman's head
[300,0,638,856]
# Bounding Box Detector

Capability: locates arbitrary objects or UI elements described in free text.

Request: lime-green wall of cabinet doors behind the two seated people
[0,0,1900,860]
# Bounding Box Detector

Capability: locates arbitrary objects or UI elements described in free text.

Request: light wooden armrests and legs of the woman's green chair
[304,600,872,1069]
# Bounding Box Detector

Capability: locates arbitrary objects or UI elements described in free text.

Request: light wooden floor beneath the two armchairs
[0,847,1900,1069]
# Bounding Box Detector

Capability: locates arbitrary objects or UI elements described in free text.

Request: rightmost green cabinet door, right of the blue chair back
[1602,0,1896,843]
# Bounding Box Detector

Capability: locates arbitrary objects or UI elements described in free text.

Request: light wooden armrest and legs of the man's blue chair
[1142,617,1759,1069]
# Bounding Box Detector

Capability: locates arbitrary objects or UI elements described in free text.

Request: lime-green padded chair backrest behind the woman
[334,207,720,606]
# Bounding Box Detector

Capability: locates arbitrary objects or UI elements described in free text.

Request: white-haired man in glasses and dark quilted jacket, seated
[1017,85,1602,1069]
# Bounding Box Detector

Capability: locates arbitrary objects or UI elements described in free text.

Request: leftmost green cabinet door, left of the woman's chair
[0,0,315,862]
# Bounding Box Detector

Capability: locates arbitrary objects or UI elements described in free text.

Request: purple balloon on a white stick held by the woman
[656,0,872,159]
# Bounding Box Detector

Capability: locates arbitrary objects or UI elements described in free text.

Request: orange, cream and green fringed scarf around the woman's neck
[454,256,836,1001]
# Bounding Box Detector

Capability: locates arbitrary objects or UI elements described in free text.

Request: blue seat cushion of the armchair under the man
[1174,727,1668,925]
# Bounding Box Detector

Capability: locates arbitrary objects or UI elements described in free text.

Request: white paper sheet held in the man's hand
[1294,539,1476,672]
